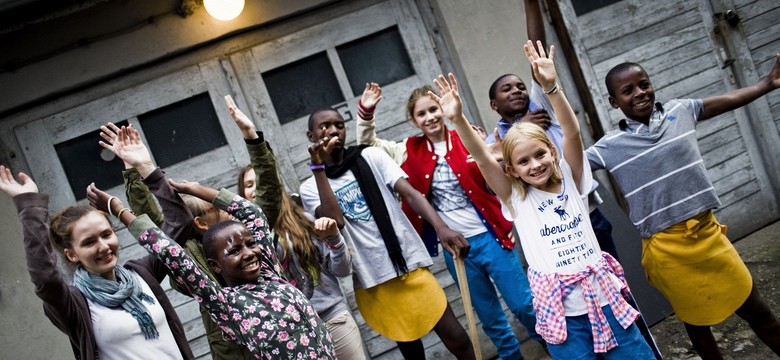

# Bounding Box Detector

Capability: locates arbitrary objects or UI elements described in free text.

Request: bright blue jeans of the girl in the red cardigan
[443,231,543,359]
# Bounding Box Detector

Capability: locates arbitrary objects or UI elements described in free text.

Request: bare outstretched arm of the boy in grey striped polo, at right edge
[699,53,780,121]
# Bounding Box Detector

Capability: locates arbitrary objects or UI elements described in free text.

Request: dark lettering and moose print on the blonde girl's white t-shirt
[536,196,597,272]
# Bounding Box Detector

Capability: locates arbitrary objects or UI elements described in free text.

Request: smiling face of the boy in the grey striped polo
[608,66,655,124]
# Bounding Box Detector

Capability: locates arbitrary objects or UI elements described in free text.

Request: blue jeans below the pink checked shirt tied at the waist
[547,305,655,360]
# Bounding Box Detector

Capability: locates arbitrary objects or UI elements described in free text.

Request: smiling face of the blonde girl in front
[506,139,559,192]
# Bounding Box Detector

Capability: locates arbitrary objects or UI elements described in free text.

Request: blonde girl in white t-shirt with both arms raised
[430,41,655,359]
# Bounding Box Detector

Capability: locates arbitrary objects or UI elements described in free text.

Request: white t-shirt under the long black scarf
[300,147,433,288]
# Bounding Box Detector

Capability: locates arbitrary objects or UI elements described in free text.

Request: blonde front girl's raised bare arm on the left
[429,74,512,204]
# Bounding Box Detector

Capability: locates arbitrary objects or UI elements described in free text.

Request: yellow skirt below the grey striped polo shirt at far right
[642,211,753,326]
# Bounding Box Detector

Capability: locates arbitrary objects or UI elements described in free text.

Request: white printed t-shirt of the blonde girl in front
[501,160,622,316]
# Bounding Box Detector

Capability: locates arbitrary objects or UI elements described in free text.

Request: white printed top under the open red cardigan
[430,141,487,238]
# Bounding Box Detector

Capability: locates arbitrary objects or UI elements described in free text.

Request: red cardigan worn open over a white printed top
[401,130,515,255]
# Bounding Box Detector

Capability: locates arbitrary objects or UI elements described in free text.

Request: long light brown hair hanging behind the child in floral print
[274,191,320,284]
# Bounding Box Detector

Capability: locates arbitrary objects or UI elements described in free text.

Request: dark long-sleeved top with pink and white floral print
[134,189,336,359]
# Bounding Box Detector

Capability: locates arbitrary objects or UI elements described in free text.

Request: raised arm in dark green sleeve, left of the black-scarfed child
[225,95,283,228]
